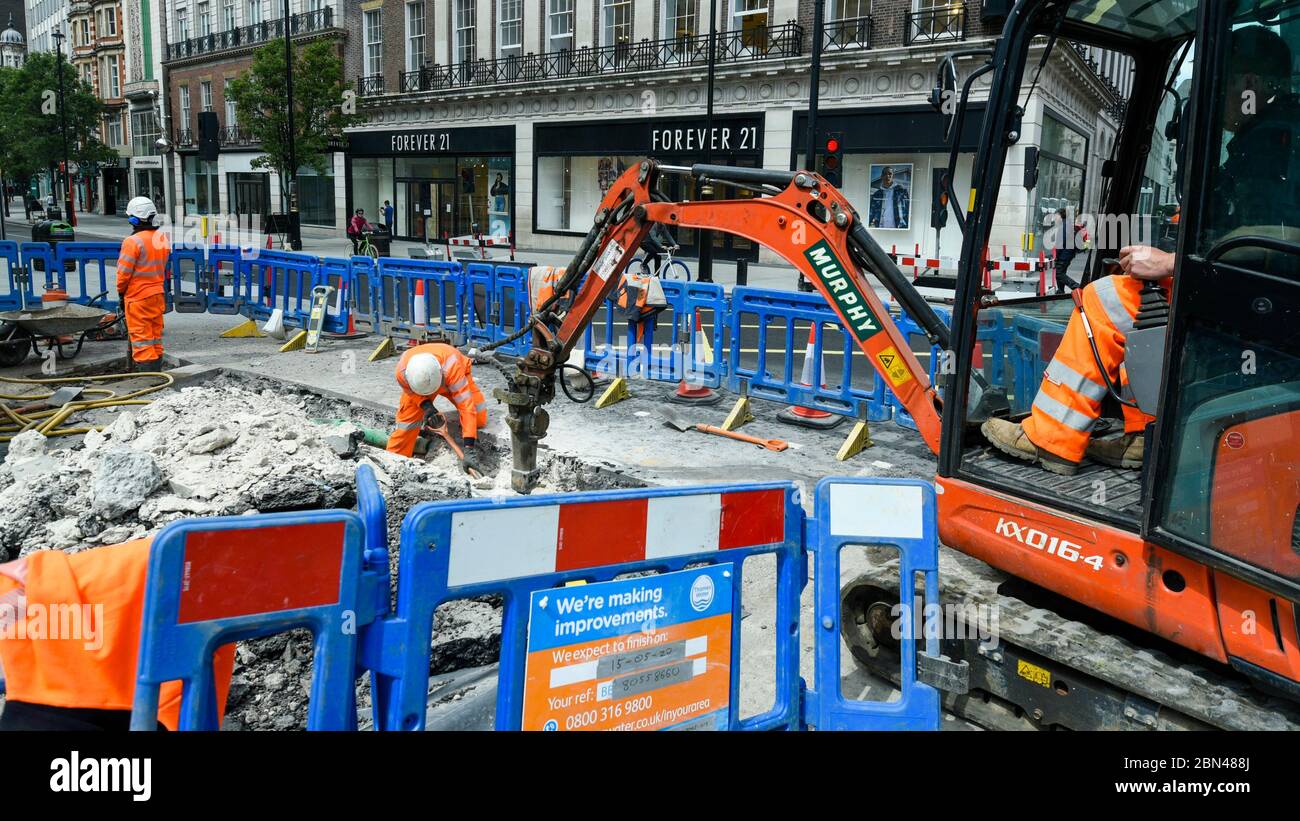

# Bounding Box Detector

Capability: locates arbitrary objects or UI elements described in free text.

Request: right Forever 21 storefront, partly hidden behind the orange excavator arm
[533,114,763,260]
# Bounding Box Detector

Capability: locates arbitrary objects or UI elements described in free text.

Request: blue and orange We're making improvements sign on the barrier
[523,564,735,730]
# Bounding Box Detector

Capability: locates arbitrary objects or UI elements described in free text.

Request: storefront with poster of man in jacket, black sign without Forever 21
[792,103,984,256]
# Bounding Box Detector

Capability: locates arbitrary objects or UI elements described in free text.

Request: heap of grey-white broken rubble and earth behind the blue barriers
[0,369,644,730]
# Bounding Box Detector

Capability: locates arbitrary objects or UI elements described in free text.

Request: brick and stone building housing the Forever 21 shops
[346,0,1126,260]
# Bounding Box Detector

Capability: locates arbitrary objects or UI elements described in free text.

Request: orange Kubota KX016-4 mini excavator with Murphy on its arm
[488,0,1300,729]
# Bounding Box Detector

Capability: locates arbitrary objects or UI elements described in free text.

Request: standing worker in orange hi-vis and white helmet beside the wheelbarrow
[117,196,172,368]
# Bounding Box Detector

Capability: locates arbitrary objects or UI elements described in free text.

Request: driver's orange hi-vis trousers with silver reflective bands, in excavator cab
[1022,268,1169,462]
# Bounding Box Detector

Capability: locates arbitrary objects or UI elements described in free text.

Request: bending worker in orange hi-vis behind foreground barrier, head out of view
[0,539,234,731]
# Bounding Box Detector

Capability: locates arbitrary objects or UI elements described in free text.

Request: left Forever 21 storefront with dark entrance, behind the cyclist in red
[345,126,515,242]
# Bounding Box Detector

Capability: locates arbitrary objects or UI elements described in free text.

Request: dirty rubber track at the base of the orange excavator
[841,547,1300,730]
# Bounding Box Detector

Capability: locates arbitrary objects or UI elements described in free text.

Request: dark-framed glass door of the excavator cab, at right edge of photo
[1143,0,1300,602]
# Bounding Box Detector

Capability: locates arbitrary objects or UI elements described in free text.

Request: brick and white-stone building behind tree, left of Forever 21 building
[164,0,347,233]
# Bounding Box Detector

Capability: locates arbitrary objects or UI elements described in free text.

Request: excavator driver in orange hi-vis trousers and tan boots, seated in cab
[980,246,1174,475]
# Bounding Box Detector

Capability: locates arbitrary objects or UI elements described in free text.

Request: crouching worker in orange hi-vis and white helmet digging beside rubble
[387,342,488,473]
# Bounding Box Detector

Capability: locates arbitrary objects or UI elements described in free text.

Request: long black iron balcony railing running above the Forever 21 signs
[384,21,803,96]
